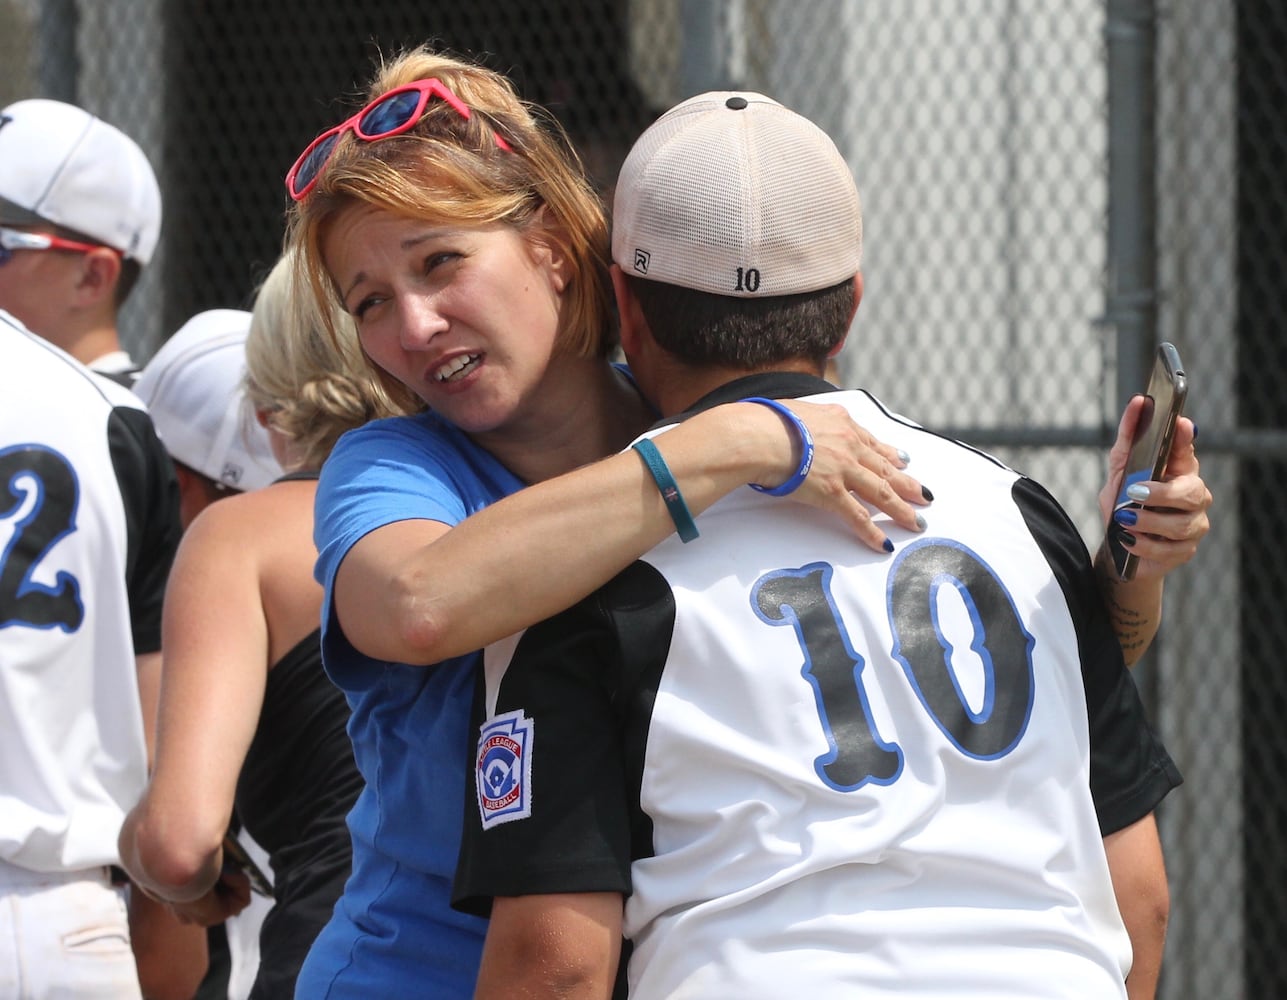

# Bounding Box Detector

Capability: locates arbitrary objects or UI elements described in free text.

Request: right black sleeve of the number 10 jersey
[1014,479,1183,837]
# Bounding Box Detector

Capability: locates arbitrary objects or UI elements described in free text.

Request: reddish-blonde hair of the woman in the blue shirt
[290,41,616,370]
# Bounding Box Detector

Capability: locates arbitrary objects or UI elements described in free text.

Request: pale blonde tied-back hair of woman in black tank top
[246,251,407,468]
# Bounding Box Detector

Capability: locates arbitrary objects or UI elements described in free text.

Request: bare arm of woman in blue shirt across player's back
[335,400,928,664]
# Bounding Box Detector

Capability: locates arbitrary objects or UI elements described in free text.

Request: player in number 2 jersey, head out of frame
[0,303,190,997]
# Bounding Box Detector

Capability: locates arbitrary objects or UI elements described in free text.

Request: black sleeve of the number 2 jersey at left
[107,407,183,655]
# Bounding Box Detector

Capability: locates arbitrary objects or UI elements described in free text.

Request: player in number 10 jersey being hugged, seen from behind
[456,93,1180,1000]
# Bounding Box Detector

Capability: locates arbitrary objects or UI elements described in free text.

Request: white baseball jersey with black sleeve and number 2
[0,311,180,871]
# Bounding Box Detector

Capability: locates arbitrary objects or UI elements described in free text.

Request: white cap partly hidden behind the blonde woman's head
[134,309,282,490]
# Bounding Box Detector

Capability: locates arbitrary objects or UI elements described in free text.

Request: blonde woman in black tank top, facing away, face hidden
[120,257,394,997]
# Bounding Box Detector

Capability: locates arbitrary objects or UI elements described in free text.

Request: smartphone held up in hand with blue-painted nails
[1108,344,1189,580]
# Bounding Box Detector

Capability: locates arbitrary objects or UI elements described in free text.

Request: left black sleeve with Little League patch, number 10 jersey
[453,576,631,915]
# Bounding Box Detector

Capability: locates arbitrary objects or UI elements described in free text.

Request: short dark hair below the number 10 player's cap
[627,275,853,372]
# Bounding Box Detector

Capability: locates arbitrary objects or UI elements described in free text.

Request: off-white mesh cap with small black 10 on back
[613,91,862,299]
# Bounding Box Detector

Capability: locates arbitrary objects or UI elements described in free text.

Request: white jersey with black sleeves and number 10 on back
[457,376,1179,1000]
